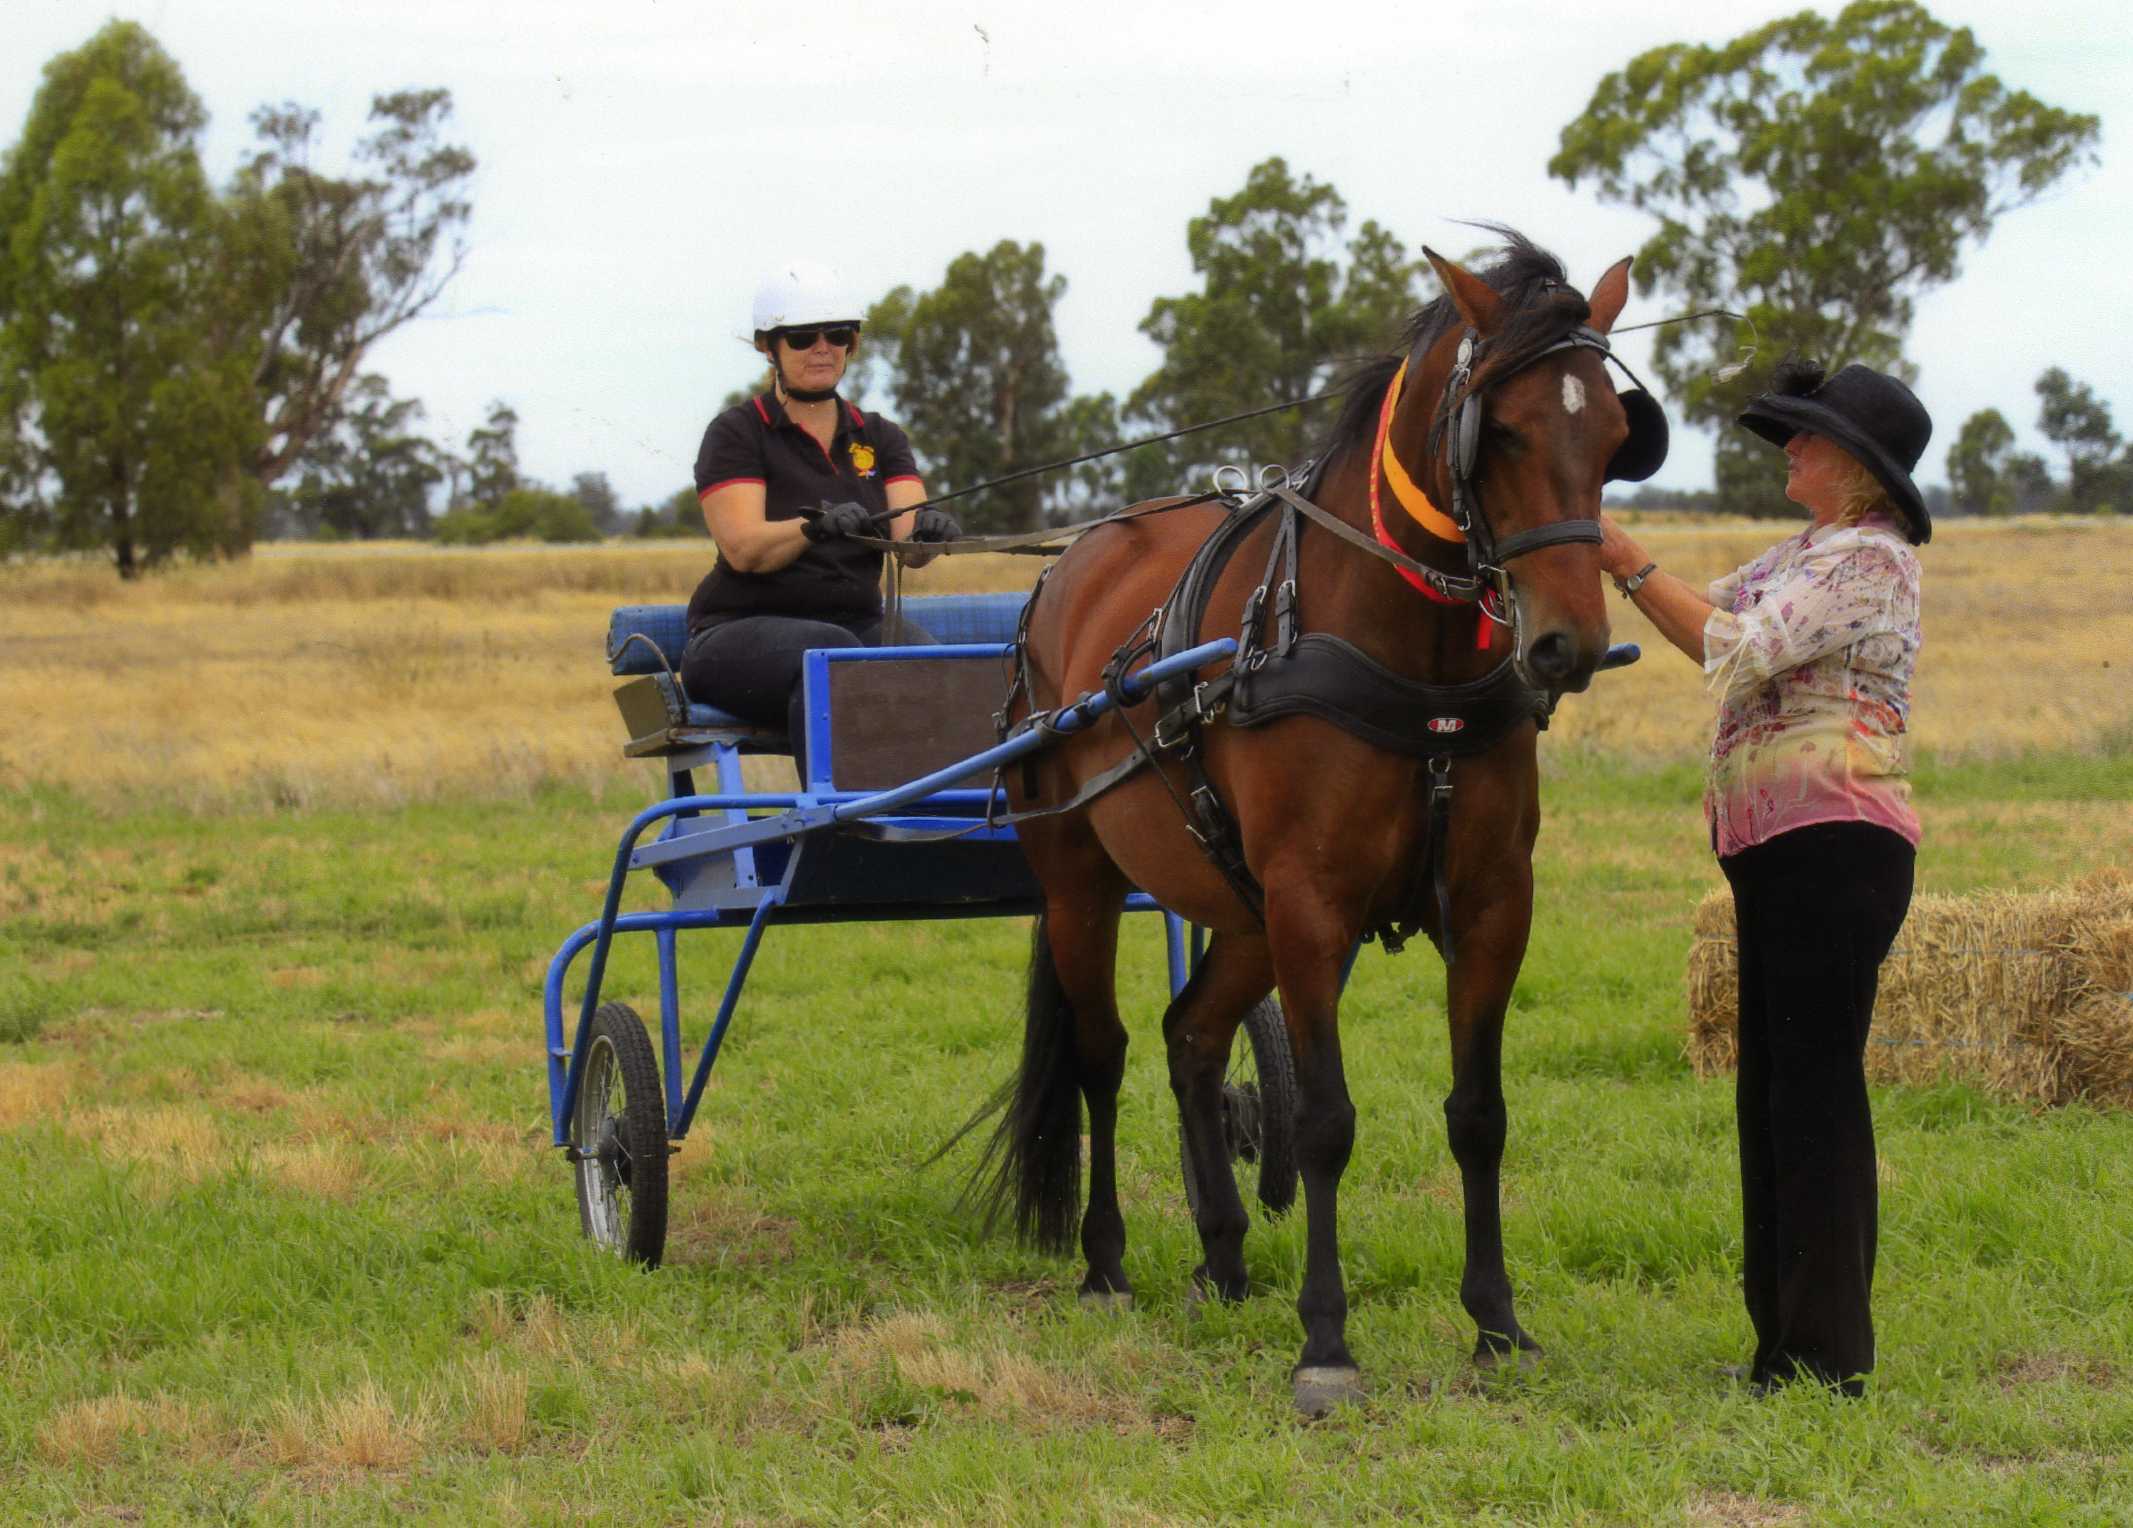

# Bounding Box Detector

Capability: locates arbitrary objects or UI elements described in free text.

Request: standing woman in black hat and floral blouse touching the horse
[1600,363,1932,1396]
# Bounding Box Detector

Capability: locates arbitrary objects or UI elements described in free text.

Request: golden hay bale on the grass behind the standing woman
[1685,871,2133,1108]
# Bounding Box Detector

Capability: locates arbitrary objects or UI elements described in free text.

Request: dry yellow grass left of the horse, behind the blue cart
[0,542,1037,809]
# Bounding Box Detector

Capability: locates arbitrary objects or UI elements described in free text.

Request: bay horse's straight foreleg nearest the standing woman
[1444,877,1540,1366]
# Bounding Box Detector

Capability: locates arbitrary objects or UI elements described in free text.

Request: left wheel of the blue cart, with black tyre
[570,1003,668,1268]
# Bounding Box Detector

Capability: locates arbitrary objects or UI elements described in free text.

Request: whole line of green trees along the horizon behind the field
[0,0,2107,576]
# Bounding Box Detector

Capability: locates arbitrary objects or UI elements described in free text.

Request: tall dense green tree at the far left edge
[0,21,258,578]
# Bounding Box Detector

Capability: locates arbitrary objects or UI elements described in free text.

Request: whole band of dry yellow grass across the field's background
[0,519,2133,809]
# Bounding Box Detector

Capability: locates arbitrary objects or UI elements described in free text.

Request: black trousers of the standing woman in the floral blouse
[1719,822,1915,1396]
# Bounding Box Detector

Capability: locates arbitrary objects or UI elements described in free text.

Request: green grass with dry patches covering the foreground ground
[0,758,2133,1524]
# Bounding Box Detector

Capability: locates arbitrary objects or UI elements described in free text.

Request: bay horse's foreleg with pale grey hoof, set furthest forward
[1267,896,1363,1415]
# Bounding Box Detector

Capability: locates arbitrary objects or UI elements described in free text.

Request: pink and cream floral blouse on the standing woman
[1704,514,1920,856]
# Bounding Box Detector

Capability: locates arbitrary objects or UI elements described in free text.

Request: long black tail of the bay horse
[936,916,1081,1253]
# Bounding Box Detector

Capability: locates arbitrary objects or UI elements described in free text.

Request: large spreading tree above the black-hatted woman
[1549,0,2099,512]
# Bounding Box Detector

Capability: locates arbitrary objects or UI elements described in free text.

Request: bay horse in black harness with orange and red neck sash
[973,228,1666,1415]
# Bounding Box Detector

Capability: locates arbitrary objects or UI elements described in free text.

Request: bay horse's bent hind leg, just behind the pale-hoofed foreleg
[1162,935,1273,1300]
